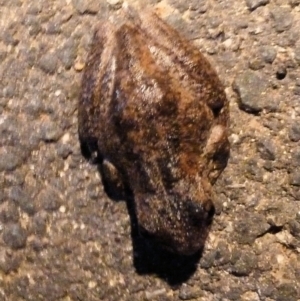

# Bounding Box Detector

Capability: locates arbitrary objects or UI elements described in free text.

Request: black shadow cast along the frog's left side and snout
[81,145,202,286]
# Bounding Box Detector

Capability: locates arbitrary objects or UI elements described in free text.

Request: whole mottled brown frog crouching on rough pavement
[78,9,229,254]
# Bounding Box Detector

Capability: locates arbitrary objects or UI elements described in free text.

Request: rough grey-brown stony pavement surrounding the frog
[0,0,300,301]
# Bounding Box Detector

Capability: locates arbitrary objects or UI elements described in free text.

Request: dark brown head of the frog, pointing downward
[136,177,215,255]
